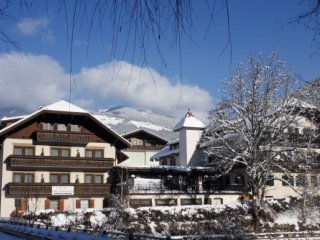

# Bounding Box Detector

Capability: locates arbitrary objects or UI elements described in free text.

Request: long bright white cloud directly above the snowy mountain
[76,61,213,116]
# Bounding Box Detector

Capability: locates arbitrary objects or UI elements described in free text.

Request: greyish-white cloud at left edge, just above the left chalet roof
[0,53,68,111]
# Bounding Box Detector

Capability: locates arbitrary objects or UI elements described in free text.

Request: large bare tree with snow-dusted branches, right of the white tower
[201,54,318,231]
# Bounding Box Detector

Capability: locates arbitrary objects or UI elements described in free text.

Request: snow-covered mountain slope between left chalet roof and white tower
[91,107,179,141]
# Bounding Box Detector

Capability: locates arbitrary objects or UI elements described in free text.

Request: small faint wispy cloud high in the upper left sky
[17,17,49,36]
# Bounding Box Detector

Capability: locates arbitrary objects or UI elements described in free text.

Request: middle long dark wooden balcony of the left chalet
[7,155,114,172]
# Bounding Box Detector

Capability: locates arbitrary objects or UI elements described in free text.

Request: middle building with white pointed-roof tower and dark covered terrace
[114,112,248,207]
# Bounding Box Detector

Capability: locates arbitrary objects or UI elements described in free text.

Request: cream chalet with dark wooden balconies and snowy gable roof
[0,101,131,217]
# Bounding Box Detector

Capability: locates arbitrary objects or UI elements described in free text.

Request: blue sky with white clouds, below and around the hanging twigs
[0,0,320,116]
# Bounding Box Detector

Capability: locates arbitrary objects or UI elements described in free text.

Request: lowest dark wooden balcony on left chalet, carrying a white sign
[5,183,110,198]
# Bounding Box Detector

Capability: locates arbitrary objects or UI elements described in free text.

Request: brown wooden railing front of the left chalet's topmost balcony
[37,132,90,145]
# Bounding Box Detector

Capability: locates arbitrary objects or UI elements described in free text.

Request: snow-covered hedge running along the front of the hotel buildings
[21,199,320,235]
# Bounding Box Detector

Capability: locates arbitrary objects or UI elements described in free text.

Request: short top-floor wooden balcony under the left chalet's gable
[35,130,92,146]
